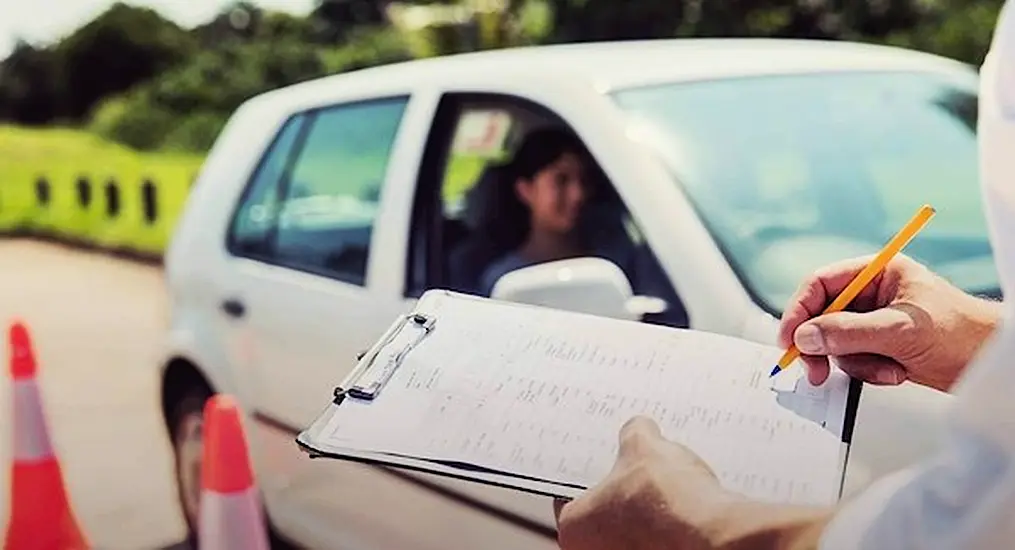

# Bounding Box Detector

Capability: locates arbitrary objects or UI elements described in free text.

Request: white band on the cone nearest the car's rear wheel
[197,487,268,550]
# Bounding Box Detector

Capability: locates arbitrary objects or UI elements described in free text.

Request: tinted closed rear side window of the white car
[232,97,408,285]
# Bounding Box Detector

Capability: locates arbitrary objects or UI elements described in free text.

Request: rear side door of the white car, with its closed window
[221,95,430,520]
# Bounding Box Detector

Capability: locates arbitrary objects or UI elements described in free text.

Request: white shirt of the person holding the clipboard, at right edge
[821,2,1015,550]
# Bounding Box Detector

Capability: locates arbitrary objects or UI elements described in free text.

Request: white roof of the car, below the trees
[274,39,973,95]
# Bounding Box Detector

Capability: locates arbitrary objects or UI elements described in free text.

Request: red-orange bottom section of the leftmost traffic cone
[3,460,89,550]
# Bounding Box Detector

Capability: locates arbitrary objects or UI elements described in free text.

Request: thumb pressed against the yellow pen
[793,307,912,357]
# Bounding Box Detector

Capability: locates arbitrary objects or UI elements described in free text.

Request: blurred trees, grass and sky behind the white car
[0,0,1001,255]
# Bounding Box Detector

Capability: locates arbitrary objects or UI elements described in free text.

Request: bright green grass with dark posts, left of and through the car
[0,126,499,255]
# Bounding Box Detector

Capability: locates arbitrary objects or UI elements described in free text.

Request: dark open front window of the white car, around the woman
[407,94,689,327]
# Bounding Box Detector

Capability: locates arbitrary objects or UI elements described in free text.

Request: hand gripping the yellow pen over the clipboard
[779,256,1001,392]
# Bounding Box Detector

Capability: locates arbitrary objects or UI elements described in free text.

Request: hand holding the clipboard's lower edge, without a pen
[554,417,829,550]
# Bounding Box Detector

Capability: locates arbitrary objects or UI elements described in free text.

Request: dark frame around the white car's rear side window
[225,92,412,288]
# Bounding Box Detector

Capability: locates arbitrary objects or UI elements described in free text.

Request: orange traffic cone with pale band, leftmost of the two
[4,323,88,550]
